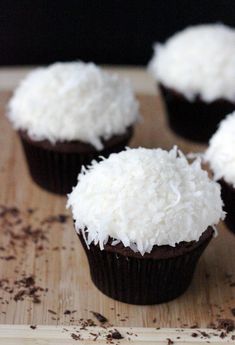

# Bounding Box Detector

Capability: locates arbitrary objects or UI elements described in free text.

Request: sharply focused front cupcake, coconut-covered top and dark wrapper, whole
[67,148,223,305]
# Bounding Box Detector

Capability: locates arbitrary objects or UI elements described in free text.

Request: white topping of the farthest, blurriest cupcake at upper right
[149,24,235,102]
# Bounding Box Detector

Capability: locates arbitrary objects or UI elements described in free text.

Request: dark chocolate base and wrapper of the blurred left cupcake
[19,128,133,195]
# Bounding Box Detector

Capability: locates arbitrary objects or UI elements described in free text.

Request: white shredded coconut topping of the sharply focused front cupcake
[67,148,224,255]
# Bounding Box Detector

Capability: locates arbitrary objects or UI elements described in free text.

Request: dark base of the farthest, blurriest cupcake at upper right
[159,84,235,143]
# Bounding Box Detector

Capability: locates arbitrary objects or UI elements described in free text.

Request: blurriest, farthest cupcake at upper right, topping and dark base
[150,24,235,142]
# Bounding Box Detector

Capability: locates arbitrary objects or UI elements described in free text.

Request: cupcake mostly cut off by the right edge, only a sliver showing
[204,112,235,233]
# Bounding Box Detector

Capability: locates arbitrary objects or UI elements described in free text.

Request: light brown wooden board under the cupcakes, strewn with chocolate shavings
[0,93,235,344]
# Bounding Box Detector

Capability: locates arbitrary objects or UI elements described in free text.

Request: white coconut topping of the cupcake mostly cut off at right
[204,112,235,188]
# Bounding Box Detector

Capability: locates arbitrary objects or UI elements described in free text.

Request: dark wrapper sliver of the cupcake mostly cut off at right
[218,179,235,234]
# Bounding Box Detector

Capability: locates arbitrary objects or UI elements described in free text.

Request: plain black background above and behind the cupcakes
[0,0,235,65]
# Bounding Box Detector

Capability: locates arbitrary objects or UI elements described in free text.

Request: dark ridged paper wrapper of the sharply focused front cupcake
[78,235,211,305]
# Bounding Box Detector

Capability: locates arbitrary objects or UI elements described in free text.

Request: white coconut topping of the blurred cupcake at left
[8,62,139,150]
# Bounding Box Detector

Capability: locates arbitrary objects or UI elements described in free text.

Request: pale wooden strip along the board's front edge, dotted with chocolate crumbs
[0,325,235,345]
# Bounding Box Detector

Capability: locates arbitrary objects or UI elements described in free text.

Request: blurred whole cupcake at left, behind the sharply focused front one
[7,62,139,194]
